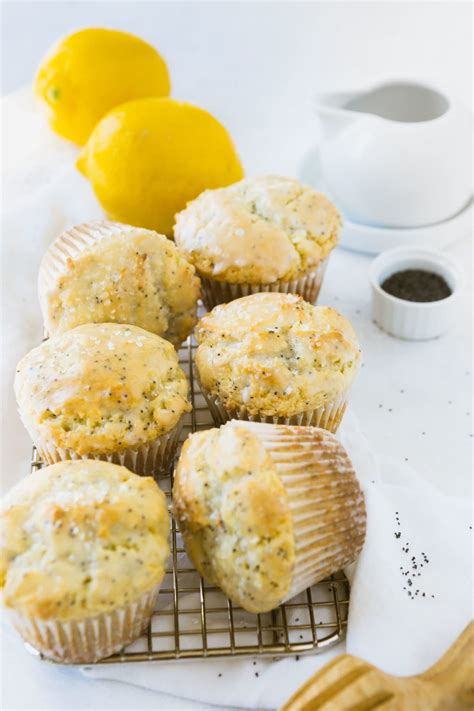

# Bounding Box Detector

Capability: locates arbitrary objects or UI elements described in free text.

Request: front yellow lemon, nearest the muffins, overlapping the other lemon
[77,98,243,235]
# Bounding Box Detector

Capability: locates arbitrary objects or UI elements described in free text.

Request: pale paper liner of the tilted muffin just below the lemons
[38,221,136,314]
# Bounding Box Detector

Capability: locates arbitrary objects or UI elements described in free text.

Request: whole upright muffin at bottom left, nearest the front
[0,460,169,663]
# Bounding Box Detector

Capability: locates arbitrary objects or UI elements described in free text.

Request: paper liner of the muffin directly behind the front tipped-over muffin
[201,384,349,432]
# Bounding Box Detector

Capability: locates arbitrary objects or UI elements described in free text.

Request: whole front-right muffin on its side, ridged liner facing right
[173,420,366,613]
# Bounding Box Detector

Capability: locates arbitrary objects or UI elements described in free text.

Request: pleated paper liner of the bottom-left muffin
[9,585,160,664]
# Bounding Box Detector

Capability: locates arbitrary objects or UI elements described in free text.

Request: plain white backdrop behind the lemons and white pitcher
[3,2,472,179]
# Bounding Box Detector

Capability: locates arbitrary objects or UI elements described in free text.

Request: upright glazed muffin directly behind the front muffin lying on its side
[196,294,360,432]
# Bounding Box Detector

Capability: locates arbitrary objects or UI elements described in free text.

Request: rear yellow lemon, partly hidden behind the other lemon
[35,28,170,145]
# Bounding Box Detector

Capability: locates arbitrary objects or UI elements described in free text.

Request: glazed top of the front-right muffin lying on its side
[173,425,295,612]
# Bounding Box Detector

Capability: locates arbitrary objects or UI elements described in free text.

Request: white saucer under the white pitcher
[300,149,474,254]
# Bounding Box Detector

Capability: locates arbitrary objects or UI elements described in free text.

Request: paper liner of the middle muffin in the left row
[33,417,183,478]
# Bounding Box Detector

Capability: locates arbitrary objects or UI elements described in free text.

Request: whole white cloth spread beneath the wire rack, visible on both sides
[2,87,471,708]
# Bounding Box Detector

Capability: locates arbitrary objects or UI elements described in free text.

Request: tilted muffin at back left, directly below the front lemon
[39,222,199,346]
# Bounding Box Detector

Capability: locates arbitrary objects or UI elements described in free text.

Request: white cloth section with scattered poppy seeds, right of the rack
[347,462,472,675]
